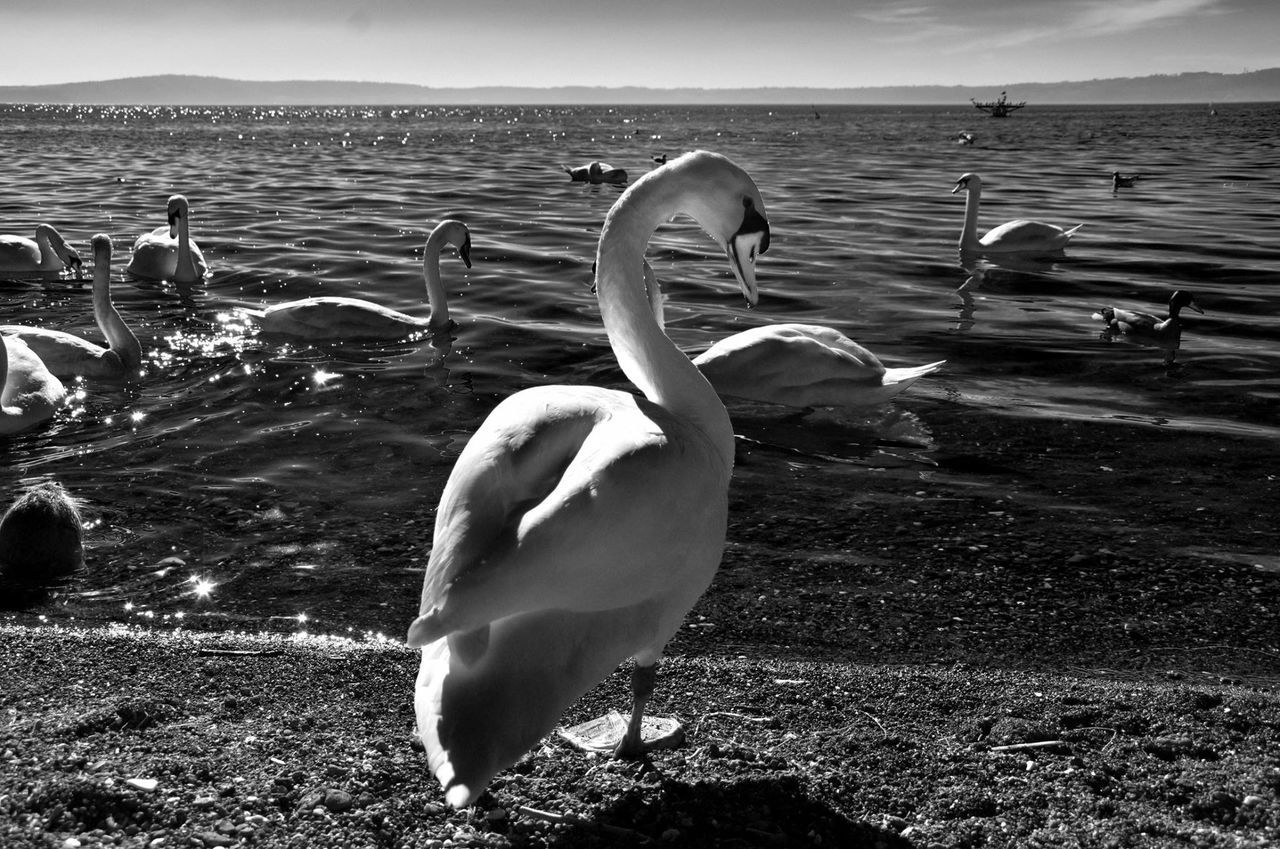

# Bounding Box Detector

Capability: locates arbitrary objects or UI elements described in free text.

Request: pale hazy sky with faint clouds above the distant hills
[0,0,1280,88]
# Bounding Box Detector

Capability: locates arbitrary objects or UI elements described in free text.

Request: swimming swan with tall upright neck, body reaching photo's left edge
[0,233,142,378]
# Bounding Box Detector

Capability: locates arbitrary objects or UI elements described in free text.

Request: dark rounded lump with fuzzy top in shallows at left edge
[0,480,84,586]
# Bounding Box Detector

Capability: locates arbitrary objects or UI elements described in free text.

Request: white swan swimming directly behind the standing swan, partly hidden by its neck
[643,263,946,408]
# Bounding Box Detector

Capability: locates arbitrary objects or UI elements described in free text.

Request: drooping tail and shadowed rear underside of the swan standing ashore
[413,606,652,808]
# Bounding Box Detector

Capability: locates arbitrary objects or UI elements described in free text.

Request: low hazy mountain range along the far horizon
[0,68,1280,106]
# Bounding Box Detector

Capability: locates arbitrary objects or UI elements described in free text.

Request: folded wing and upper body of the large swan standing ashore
[410,387,728,645]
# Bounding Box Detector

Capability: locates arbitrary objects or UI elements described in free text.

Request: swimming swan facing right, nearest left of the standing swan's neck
[237,218,471,342]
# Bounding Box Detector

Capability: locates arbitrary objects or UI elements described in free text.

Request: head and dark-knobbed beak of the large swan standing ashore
[665,150,769,306]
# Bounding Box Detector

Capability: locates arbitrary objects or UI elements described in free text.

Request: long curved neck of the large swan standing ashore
[595,181,733,469]
